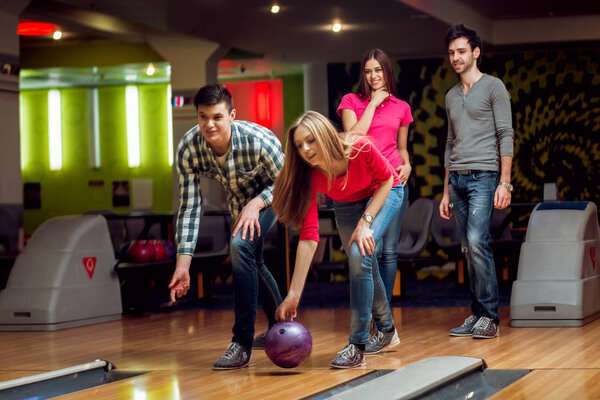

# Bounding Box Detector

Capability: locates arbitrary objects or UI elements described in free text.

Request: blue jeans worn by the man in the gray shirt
[448,171,499,322]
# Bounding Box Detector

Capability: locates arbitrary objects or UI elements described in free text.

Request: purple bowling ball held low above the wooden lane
[265,321,312,368]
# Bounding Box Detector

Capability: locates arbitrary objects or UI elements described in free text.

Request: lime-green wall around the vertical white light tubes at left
[21,84,172,234]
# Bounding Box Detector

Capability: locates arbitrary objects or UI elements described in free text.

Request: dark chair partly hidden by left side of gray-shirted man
[431,199,466,284]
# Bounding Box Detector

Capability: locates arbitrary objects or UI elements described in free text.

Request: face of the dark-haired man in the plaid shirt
[198,101,235,150]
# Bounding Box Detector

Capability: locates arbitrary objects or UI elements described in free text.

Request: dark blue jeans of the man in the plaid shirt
[231,207,282,347]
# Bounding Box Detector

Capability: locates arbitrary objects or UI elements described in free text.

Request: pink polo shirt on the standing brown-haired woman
[337,93,413,168]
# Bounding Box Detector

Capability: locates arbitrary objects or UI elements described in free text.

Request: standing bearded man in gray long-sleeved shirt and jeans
[440,24,514,339]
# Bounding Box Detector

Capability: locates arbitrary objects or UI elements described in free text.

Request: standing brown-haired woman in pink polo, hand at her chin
[337,49,413,310]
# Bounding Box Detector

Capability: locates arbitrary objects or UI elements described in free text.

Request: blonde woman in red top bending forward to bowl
[273,111,403,368]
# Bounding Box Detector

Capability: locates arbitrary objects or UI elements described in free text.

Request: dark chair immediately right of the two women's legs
[393,198,433,296]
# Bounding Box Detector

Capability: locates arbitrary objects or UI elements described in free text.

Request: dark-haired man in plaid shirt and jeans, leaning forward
[169,85,284,369]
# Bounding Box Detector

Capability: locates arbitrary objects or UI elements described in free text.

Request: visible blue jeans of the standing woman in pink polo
[375,183,408,303]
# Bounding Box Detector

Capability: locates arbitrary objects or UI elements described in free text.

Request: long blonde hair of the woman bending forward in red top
[272,111,366,226]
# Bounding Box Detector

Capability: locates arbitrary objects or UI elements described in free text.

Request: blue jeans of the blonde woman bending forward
[333,185,403,345]
